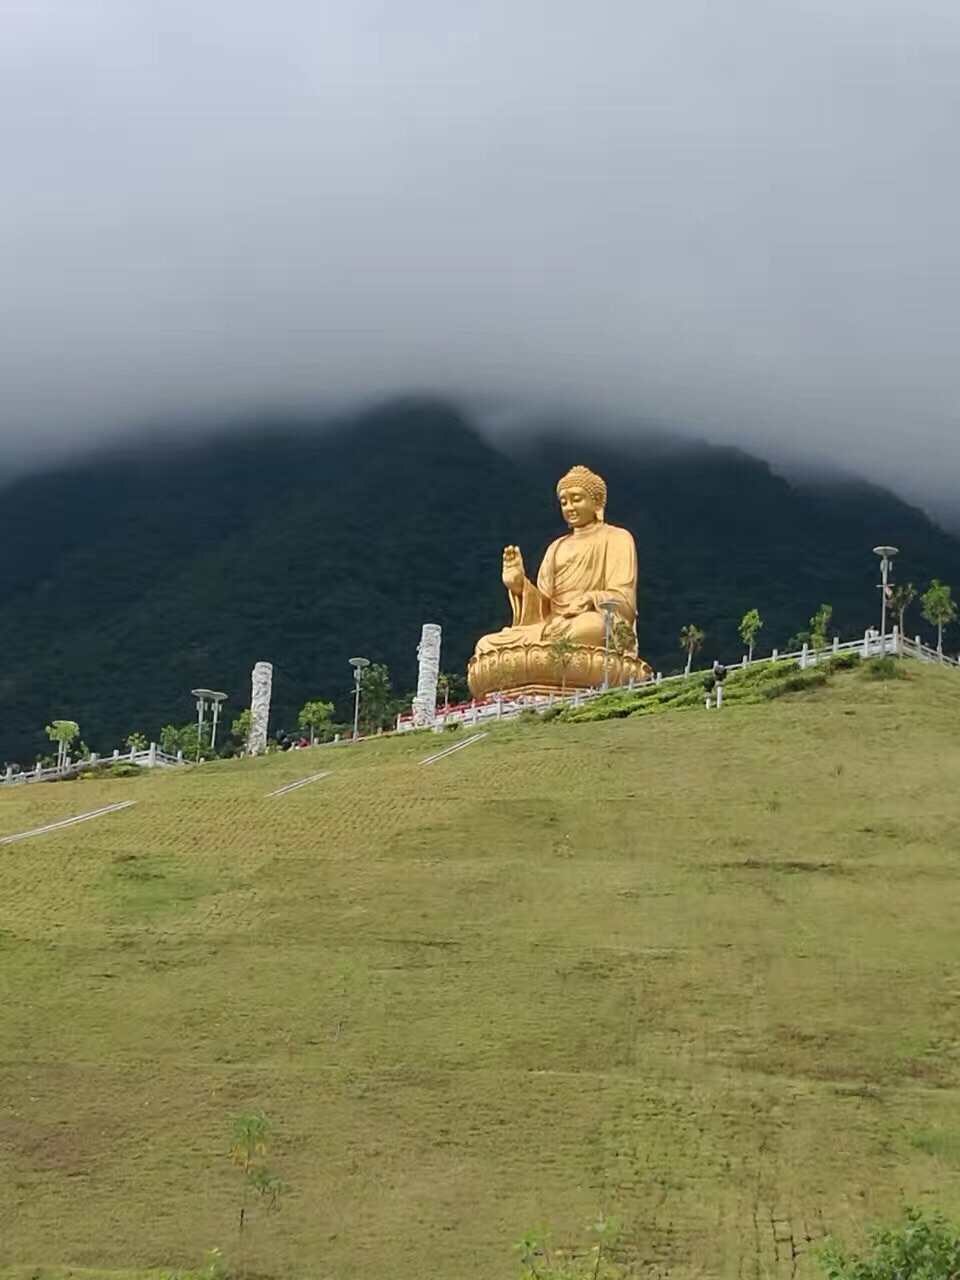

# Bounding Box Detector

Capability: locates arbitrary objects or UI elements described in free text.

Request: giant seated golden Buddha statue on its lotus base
[467,467,653,698]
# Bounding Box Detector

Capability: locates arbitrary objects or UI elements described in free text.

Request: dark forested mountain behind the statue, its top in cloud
[0,402,960,762]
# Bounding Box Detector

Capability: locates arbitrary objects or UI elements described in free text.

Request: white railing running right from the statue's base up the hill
[397,627,960,733]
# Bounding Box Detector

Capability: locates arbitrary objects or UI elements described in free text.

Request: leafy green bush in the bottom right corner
[818,1208,960,1280]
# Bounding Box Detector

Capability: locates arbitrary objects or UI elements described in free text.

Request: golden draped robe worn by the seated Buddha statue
[476,522,636,654]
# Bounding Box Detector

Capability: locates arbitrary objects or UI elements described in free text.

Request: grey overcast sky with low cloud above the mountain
[0,0,960,514]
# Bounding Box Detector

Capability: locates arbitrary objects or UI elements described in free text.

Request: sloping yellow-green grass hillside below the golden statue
[0,667,960,1280]
